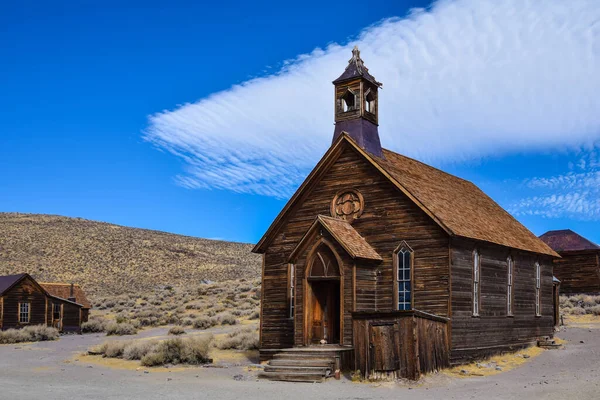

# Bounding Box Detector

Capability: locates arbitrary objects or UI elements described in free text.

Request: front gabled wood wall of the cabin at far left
[2,278,46,330]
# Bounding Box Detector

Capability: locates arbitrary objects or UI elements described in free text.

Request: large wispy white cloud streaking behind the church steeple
[145,0,600,197]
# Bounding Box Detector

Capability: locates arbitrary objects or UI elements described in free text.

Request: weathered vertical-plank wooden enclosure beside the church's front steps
[353,311,450,379]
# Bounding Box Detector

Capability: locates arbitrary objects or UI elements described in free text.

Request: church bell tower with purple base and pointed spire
[333,46,383,157]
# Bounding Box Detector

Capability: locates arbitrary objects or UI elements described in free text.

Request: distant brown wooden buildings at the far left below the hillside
[0,274,90,332]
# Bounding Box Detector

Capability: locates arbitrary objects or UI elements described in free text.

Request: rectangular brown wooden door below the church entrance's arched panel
[309,281,340,344]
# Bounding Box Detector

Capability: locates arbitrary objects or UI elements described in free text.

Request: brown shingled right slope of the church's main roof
[373,149,558,257]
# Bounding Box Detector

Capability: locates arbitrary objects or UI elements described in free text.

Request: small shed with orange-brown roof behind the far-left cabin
[40,282,92,331]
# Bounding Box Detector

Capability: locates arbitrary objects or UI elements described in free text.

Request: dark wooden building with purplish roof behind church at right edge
[540,229,600,295]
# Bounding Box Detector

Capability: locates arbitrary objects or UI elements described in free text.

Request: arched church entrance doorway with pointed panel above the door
[304,243,343,345]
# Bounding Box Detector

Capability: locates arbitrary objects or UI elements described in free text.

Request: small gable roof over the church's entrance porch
[290,215,383,261]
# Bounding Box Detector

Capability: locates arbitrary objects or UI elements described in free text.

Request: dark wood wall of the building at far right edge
[554,251,600,294]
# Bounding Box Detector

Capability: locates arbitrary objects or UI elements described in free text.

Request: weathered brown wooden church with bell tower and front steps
[253,48,558,380]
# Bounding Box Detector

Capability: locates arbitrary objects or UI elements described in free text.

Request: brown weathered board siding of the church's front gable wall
[261,145,450,349]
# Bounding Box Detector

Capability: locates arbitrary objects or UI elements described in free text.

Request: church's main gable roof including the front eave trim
[253,133,559,257]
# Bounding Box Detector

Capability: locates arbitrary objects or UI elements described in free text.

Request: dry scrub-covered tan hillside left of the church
[0,213,261,295]
